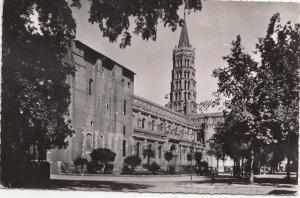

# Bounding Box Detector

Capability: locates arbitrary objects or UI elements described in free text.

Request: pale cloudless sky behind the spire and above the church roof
[72,1,300,111]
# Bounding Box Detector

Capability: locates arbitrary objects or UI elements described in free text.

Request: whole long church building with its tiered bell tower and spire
[47,18,223,174]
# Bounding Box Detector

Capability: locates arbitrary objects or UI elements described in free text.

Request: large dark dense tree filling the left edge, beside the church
[1,0,76,186]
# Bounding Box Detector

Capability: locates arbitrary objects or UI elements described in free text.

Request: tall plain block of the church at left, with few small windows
[48,41,133,173]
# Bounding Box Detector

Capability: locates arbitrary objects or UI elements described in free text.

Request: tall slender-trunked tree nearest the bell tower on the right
[213,36,258,183]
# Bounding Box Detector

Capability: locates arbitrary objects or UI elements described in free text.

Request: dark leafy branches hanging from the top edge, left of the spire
[72,0,202,48]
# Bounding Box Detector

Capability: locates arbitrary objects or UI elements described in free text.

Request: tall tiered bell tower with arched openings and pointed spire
[170,17,197,115]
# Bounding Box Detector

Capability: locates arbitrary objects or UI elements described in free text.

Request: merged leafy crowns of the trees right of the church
[213,14,300,181]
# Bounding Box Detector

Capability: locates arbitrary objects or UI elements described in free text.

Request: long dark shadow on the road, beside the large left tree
[49,180,153,191]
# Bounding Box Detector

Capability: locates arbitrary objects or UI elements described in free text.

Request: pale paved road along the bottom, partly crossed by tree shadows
[51,175,297,195]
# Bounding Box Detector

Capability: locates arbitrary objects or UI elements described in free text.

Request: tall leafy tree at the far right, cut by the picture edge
[256,13,300,178]
